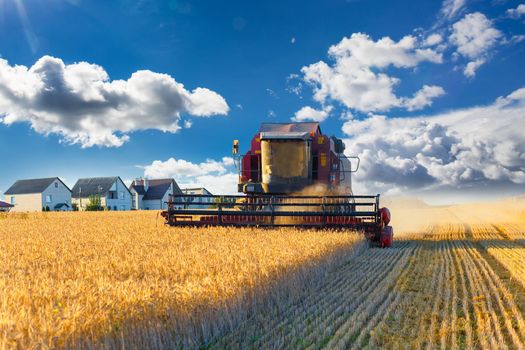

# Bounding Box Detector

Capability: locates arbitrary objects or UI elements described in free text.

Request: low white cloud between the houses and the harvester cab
[144,157,238,194]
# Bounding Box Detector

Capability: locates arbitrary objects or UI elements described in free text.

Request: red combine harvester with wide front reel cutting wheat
[162,123,393,247]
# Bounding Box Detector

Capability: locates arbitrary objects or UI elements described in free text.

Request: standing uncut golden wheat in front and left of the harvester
[0,212,363,348]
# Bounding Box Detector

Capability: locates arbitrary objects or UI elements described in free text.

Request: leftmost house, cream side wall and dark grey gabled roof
[4,177,71,212]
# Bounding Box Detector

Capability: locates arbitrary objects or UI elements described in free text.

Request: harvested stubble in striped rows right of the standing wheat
[213,205,525,349]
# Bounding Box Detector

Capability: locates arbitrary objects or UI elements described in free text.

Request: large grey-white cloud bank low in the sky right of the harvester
[343,88,525,200]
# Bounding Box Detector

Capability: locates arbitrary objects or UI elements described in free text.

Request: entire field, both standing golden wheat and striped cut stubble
[0,201,525,349]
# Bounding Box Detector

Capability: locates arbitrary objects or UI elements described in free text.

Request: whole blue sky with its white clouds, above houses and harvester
[0,0,525,202]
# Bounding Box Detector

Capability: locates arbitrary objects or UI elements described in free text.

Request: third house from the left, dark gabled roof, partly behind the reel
[129,179,182,210]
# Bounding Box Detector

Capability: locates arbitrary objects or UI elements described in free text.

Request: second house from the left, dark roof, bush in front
[72,176,131,210]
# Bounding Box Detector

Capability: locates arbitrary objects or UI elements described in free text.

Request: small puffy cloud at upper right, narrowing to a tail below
[449,12,503,77]
